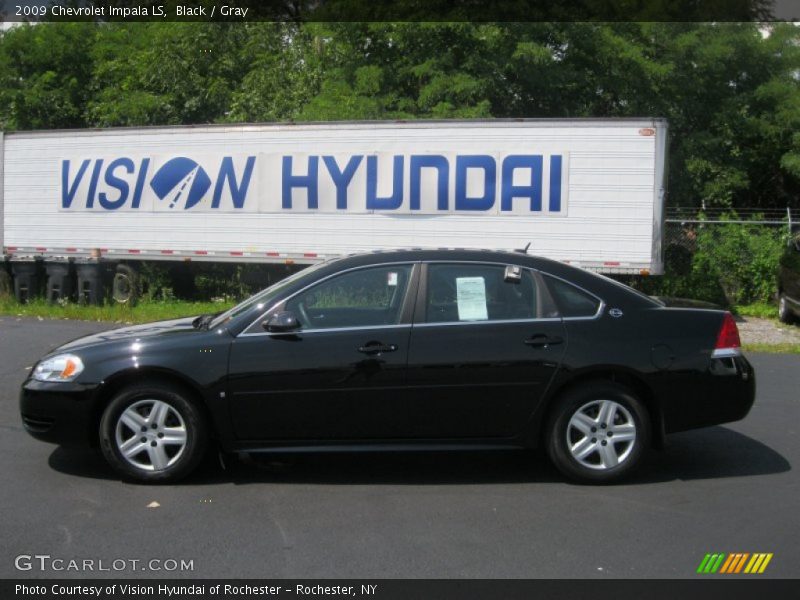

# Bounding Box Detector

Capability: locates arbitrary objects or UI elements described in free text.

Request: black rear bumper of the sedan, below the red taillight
[661,355,756,433]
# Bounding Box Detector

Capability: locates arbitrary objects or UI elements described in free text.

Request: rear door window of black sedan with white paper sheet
[425,263,538,323]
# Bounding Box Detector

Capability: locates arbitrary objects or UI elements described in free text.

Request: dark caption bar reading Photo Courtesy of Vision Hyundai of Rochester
[0,576,800,600]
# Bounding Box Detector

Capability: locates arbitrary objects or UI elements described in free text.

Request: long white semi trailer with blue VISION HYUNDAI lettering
[0,118,667,302]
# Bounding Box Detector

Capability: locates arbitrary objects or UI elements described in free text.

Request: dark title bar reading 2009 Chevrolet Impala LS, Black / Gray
[0,0,800,22]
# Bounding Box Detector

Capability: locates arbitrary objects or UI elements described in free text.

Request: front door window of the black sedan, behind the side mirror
[285,265,412,329]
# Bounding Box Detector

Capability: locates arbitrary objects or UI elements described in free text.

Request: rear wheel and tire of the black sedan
[546,381,650,484]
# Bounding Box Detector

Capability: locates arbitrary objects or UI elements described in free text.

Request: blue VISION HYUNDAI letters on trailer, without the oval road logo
[61,154,564,213]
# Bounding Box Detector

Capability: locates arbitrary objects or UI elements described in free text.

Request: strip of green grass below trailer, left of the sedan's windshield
[0,296,233,324]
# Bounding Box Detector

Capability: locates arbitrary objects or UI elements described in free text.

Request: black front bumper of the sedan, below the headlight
[19,379,99,446]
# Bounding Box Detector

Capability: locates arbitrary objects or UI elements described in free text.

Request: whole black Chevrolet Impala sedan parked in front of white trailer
[20,250,755,483]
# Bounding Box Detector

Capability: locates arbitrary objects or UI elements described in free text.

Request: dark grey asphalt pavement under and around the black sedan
[0,316,800,579]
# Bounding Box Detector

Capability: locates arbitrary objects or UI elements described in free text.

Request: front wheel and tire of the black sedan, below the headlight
[100,383,208,483]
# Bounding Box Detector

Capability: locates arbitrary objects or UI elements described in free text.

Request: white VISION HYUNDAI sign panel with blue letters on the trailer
[59,152,569,216]
